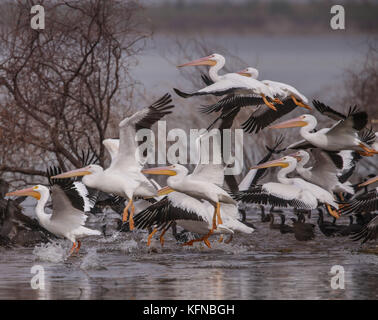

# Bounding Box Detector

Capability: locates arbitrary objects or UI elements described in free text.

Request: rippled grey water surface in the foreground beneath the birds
[0,210,378,299]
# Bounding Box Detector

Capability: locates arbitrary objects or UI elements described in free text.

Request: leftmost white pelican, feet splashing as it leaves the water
[6,171,101,254]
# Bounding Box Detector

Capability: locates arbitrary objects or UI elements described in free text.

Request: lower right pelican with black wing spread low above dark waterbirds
[233,156,339,218]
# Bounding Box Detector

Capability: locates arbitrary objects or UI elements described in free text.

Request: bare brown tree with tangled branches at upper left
[0,0,148,183]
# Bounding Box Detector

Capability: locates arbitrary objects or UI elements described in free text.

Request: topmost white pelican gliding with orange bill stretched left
[174,53,278,111]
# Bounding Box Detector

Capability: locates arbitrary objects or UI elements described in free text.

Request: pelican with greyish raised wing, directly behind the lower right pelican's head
[294,149,354,194]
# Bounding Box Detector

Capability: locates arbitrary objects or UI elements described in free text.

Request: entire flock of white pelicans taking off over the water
[3,53,378,253]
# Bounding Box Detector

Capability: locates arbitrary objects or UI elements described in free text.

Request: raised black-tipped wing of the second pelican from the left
[111,93,174,169]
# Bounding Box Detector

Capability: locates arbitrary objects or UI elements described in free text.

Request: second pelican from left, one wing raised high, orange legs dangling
[54,94,174,230]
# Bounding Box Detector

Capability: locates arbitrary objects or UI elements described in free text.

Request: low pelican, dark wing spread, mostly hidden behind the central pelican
[135,188,254,248]
